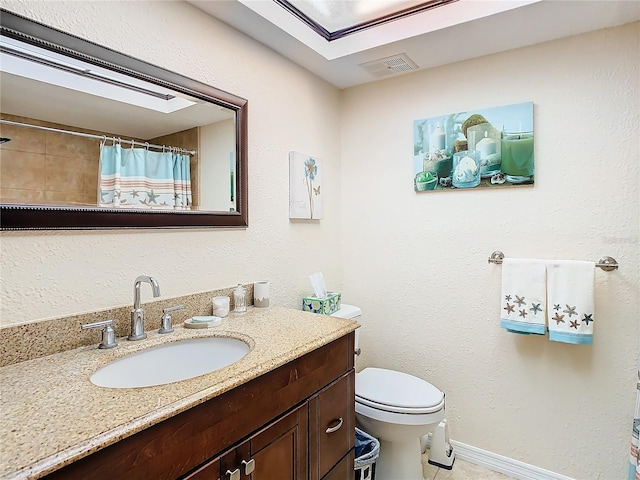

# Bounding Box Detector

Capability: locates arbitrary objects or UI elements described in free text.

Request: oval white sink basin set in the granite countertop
[90,337,249,388]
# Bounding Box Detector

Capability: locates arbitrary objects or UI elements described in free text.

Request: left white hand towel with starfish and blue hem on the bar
[500,258,547,335]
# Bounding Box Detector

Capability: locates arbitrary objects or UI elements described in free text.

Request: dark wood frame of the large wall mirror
[0,9,248,230]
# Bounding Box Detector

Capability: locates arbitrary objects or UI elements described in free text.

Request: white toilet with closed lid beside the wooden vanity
[333,304,455,480]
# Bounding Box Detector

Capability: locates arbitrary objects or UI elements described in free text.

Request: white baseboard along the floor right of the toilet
[426,434,574,480]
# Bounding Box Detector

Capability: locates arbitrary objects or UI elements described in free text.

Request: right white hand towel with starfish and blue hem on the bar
[547,260,596,345]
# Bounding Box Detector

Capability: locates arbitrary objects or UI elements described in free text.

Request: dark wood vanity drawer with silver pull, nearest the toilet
[309,370,355,480]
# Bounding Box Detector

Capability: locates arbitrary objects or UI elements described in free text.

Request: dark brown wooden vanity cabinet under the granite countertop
[45,333,355,480]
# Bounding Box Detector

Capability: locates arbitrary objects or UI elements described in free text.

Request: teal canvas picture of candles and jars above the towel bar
[413,102,534,192]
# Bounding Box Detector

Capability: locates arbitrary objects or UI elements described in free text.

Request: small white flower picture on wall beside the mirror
[289,152,323,220]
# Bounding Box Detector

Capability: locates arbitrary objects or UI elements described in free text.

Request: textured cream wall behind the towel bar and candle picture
[342,23,640,480]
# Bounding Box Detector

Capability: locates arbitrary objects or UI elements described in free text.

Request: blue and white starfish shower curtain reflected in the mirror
[98,143,192,210]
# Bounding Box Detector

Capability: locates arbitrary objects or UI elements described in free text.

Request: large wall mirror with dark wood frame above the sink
[0,9,248,230]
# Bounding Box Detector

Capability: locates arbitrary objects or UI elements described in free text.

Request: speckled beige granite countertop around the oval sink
[0,306,359,480]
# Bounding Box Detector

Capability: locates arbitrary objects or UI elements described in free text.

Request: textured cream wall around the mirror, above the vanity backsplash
[0,1,342,324]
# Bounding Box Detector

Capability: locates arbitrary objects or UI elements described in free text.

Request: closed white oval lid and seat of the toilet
[356,367,444,414]
